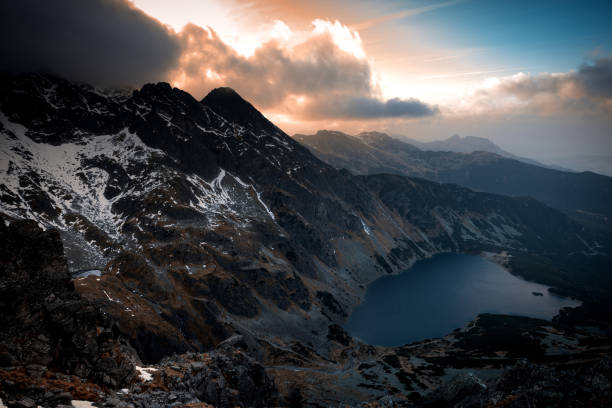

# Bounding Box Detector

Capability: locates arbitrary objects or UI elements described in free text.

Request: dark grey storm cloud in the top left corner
[0,0,181,86]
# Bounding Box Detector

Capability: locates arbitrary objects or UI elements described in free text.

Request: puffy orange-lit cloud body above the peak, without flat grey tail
[173,24,371,108]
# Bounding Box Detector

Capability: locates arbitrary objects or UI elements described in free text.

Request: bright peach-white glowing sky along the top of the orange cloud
[135,0,492,108]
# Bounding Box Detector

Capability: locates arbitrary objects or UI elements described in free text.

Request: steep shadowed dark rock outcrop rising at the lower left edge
[0,215,134,404]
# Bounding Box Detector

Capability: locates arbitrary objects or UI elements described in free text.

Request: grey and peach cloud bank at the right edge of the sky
[455,59,612,116]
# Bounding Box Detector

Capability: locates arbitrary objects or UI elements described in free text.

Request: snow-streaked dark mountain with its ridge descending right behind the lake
[0,71,609,362]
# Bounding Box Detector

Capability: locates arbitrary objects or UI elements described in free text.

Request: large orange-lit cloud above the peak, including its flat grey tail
[173,20,437,119]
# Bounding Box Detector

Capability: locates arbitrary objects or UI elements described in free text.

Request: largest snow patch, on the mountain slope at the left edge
[0,113,164,239]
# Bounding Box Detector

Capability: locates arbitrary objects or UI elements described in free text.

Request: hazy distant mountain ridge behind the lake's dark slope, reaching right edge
[294,131,612,228]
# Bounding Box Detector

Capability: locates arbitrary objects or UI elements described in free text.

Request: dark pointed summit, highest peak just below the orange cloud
[201,87,277,131]
